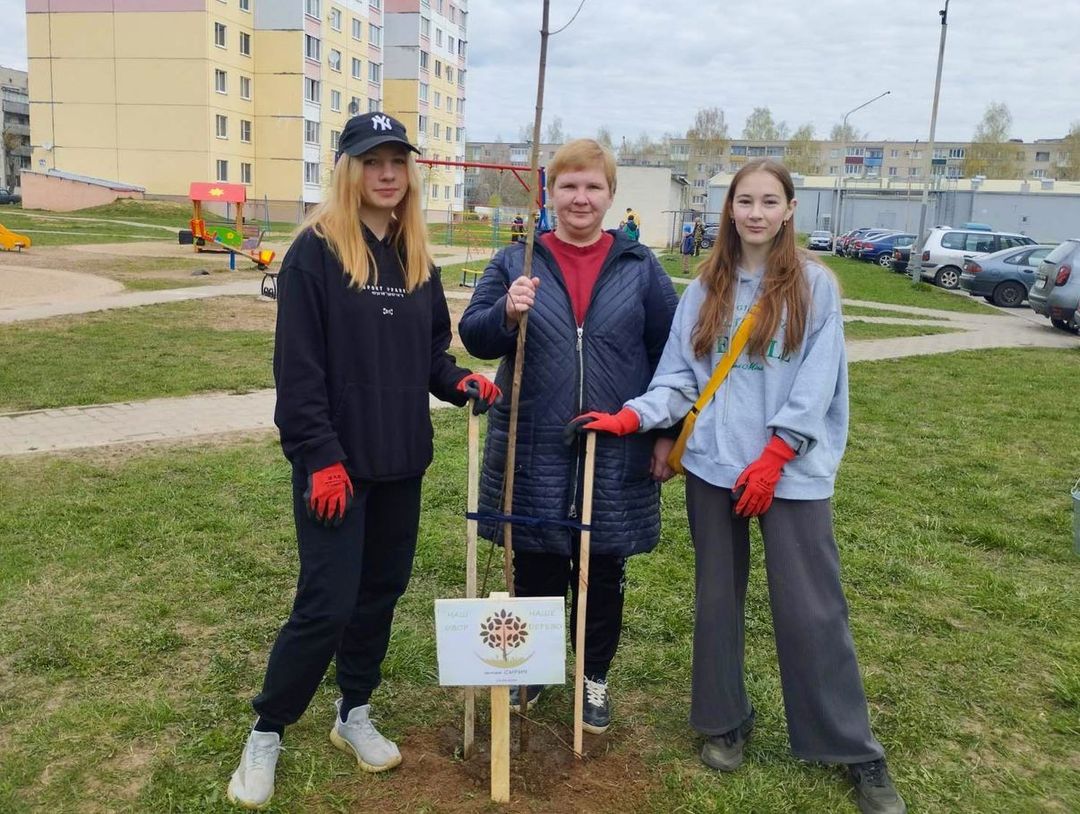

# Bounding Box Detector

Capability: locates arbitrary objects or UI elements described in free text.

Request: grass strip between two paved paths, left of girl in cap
[0,297,273,410]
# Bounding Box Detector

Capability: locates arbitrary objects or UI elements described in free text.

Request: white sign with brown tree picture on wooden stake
[435,596,566,687]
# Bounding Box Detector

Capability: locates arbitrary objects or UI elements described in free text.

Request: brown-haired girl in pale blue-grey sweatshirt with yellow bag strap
[573,160,906,814]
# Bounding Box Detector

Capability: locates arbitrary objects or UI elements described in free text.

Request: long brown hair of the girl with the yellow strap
[692,159,809,357]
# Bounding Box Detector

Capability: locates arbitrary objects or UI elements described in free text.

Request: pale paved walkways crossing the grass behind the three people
[0,281,1080,456]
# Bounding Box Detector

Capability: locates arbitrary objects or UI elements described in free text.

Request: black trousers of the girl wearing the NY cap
[253,471,421,725]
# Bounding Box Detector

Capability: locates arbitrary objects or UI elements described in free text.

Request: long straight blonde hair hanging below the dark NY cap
[298,152,432,291]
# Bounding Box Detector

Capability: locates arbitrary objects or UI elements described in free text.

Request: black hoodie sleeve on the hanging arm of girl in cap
[273,247,346,473]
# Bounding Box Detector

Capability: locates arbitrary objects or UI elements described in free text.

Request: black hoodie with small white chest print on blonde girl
[273,228,469,481]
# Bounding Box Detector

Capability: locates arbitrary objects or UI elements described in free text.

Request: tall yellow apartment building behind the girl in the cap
[27,0,455,219]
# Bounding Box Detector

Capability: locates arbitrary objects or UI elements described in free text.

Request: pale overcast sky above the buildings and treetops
[0,0,1080,143]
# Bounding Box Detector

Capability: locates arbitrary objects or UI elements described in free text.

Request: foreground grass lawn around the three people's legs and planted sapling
[0,350,1080,814]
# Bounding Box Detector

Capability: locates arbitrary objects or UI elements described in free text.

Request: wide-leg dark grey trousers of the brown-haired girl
[686,473,883,763]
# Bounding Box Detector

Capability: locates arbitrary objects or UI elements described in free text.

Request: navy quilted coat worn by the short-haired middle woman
[459,228,677,556]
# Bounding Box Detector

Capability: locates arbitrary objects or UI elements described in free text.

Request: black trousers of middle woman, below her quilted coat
[514,542,626,678]
